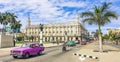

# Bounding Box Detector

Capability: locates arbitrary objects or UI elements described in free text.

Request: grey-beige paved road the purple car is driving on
[0,45,81,62]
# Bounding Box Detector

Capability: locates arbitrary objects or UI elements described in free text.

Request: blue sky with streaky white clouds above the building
[0,0,120,34]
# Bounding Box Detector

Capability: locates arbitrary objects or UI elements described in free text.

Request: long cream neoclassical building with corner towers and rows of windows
[23,13,88,41]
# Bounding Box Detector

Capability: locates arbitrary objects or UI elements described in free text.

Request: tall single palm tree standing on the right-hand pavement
[81,3,118,52]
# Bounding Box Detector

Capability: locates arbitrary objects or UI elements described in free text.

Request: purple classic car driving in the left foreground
[11,43,44,58]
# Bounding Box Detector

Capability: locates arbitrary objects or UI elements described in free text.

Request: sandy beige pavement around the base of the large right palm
[76,42,120,62]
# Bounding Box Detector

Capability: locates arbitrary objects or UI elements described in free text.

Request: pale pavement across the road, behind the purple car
[0,43,62,57]
